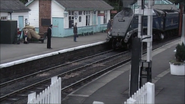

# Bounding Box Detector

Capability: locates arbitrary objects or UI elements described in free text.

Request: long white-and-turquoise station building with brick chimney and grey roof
[25,0,113,37]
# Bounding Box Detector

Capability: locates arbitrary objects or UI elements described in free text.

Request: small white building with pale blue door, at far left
[0,0,30,30]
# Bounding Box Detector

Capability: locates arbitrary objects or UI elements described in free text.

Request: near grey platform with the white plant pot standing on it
[63,39,185,104]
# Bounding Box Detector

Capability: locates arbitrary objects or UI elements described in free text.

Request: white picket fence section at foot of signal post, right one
[124,82,155,104]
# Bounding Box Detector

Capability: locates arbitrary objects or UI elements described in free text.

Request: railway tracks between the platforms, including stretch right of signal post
[0,36,179,104]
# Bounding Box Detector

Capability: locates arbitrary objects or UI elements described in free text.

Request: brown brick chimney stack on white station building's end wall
[39,0,51,34]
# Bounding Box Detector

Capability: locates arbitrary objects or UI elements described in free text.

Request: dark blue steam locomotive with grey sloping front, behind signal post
[109,8,179,49]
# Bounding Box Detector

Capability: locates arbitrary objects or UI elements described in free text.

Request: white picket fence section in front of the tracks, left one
[28,77,61,104]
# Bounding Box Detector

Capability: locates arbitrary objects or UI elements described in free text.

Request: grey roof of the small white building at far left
[0,0,30,12]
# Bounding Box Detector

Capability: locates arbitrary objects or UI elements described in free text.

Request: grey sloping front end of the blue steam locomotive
[111,7,134,49]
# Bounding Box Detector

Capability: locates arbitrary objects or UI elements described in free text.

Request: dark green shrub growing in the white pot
[175,43,185,62]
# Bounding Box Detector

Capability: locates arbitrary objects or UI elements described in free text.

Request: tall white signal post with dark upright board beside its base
[129,0,154,96]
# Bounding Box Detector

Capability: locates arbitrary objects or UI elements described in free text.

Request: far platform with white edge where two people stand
[0,33,107,64]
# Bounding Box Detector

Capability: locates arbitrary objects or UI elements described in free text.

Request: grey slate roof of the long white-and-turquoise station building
[56,0,113,10]
